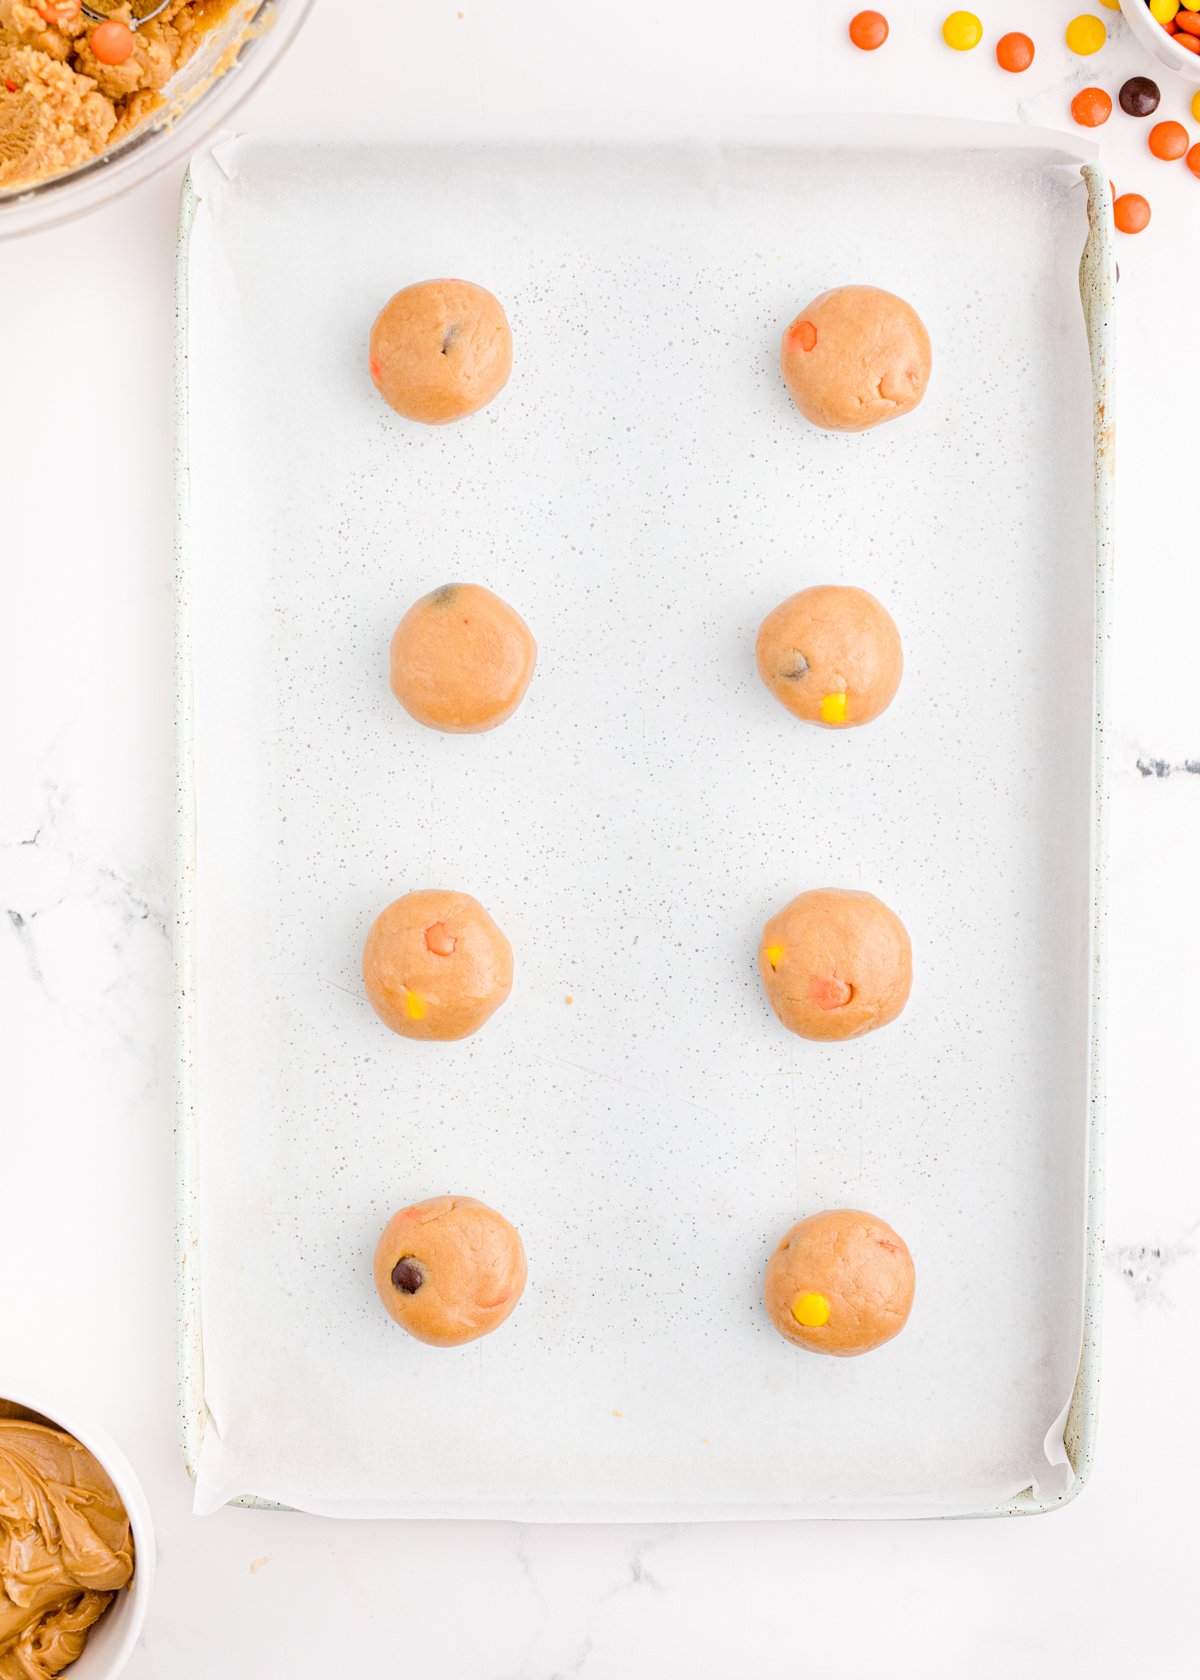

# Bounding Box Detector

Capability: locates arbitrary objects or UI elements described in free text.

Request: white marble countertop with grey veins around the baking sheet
[0,0,1200,1680]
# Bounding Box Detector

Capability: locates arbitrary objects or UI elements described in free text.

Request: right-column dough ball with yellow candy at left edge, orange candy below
[758,887,913,1040]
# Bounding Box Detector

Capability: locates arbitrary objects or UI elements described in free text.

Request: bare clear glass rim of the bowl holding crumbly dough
[0,0,313,239]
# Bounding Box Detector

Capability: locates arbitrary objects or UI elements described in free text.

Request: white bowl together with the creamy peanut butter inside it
[0,1373,155,1680]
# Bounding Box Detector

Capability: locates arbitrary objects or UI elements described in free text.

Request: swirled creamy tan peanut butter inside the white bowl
[0,1418,133,1680]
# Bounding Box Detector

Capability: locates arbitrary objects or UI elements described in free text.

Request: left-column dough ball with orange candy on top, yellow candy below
[363,892,513,1040]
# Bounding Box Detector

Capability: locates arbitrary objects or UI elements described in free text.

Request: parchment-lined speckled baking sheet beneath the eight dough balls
[173,136,1096,1519]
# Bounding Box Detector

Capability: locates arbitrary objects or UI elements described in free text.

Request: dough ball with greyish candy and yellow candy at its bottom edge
[755,583,904,729]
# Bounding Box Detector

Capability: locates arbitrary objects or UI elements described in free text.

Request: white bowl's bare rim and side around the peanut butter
[0,1371,155,1680]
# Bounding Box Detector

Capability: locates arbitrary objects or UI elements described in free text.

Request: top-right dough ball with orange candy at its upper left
[780,286,931,432]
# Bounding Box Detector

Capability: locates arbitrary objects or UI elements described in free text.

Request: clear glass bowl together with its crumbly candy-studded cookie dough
[0,0,313,239]
